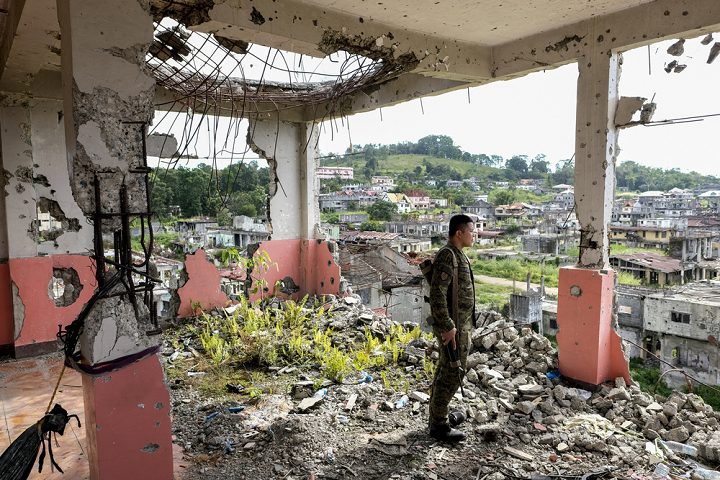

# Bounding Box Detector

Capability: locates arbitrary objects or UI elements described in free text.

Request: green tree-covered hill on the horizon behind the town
[321,135,720,191]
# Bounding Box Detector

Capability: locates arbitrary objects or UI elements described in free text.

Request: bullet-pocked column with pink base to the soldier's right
[557,29,630,385]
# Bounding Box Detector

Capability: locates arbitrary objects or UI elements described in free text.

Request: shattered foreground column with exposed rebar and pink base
[58,0,172,480]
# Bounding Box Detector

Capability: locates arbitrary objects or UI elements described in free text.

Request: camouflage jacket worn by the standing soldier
[430,243,475,333]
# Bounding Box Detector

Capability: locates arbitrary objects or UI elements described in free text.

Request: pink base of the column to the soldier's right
[557,267,632,385]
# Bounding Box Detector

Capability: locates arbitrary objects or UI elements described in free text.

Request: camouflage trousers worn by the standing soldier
[430,331,470,425]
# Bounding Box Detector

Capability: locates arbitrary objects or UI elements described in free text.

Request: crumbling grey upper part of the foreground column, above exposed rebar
[59,0,155,229]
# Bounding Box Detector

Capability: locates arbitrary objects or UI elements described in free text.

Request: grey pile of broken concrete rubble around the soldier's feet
[165,296,720,480]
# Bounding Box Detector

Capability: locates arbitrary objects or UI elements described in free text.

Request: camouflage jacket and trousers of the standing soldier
[430,243,475,425]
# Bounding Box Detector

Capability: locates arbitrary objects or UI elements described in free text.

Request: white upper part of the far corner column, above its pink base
[248,121,320,240]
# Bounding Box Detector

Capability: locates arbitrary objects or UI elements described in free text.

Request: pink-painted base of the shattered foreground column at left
[82,355,173,480]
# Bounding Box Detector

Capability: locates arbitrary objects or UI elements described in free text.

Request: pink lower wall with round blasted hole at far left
[9,255,96,346]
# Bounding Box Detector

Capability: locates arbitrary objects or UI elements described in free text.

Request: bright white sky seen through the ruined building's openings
[150,35,720,176]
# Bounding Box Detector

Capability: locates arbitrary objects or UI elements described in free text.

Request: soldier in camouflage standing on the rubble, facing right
[430,215,475,442]
